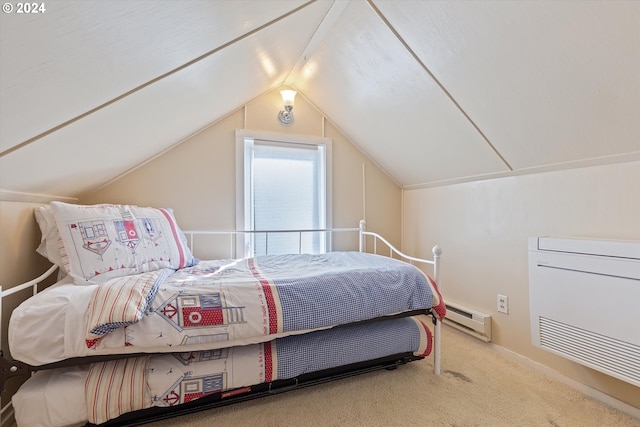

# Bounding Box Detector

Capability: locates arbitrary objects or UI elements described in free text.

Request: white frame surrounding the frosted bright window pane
[235,129,333,257]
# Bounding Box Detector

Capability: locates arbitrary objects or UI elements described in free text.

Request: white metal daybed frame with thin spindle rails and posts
[0,220,442,426]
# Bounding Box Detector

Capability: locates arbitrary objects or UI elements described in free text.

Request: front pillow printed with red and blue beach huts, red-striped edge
[51,202,197,284]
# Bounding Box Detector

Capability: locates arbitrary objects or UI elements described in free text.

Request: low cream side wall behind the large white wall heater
[403,161,640,408]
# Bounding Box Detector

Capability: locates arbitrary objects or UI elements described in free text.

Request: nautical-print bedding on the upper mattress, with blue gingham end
[9,252,444,366]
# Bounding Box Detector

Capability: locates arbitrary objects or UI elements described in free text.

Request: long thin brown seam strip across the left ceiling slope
[0,0,317,158]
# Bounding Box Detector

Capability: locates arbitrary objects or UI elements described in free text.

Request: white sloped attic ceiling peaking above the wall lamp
[0,0,640,201]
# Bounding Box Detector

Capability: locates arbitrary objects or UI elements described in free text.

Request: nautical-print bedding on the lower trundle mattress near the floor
[13,316,432,427]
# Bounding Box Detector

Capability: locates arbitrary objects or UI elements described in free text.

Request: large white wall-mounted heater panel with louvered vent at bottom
[529,237,640,386]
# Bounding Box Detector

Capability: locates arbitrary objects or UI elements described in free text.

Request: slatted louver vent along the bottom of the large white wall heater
[539,317,640,384]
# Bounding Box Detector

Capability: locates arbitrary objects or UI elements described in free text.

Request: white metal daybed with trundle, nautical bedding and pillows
[2,202,445,427]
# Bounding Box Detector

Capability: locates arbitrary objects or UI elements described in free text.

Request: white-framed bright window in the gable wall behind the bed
[236,131,331,257]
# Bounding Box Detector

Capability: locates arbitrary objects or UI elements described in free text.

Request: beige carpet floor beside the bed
[142,326,640,427]
